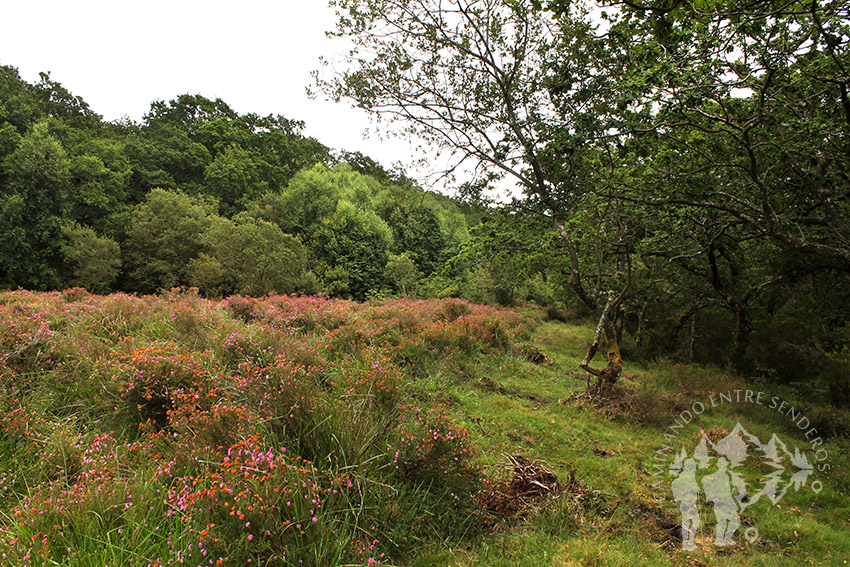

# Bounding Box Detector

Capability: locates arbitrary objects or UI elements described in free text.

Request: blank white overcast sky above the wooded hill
[0,0,439,184]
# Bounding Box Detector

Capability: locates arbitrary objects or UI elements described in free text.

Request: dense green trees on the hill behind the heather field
[0,66,478,300]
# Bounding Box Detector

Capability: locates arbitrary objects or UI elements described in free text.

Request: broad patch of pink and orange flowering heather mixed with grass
[0,289,525,567]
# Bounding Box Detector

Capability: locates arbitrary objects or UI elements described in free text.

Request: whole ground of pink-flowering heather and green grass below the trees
[0,290,850,567]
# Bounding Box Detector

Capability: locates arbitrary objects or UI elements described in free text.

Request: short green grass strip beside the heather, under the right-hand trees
[411,323,850,567]
